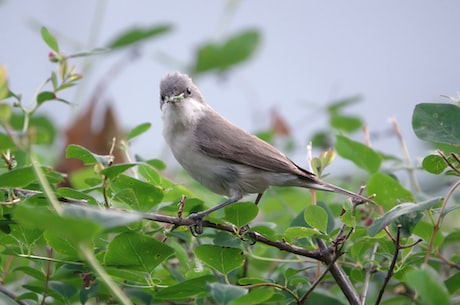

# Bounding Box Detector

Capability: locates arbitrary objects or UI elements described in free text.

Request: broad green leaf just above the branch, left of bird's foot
[110,175,163,211]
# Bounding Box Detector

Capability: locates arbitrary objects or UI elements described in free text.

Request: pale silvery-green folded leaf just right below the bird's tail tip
[367,197,442,236]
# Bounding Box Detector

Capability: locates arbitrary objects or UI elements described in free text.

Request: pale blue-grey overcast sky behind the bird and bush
[0,0,460,173]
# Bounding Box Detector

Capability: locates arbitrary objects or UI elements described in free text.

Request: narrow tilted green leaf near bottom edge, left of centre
[155,275,216,301]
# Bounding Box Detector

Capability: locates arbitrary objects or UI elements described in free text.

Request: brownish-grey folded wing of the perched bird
[195,111,315,179]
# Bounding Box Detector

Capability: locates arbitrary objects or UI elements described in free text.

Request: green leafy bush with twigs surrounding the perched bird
[0,25,460,305]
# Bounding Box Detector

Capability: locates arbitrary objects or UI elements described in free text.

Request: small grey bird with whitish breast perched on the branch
[160,72,372,233]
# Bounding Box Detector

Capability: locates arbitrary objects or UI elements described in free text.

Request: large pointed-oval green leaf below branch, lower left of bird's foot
[104,232,174,273]
